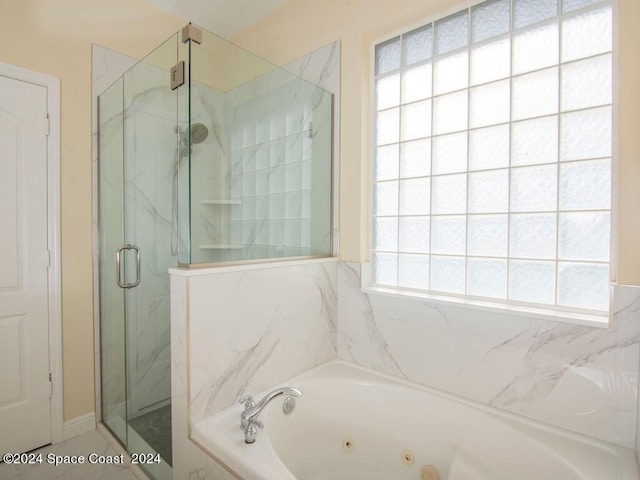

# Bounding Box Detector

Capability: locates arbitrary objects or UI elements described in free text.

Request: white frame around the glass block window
[361,0,619,328]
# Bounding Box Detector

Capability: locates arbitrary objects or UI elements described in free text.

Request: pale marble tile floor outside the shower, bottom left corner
[0,430,137,480]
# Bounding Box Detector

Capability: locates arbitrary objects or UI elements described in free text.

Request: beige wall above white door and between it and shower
[0,0,184,420]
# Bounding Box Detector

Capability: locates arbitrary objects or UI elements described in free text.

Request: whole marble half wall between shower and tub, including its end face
[171,258,338,479]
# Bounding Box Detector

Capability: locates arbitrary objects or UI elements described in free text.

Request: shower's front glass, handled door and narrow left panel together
[99,35,184,480]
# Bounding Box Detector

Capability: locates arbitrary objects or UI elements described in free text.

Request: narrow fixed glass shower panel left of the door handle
[98,78,127,444]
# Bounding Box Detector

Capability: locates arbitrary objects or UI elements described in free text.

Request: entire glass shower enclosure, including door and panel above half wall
[98,25,333,479]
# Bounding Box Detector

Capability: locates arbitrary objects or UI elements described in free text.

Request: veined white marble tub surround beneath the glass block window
[338,263,640,448]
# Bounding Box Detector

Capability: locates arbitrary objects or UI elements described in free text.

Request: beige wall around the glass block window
[233,0,640,284]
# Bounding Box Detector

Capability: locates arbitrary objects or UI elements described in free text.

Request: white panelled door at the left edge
[0,72,51,453]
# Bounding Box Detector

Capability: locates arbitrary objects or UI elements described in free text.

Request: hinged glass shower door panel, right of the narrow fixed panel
[121,35,176,476]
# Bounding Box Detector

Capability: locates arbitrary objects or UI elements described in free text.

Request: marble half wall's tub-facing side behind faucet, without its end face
[189,261,337,424]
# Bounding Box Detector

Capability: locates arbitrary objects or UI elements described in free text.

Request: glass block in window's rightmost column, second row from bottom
[558,212,611,262]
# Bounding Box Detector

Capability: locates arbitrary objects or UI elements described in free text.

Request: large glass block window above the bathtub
[372,0,612,312]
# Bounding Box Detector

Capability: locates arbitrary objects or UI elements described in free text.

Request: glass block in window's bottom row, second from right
[509,260,556,305]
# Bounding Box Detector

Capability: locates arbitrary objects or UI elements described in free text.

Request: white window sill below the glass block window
[361,284,609,328]
